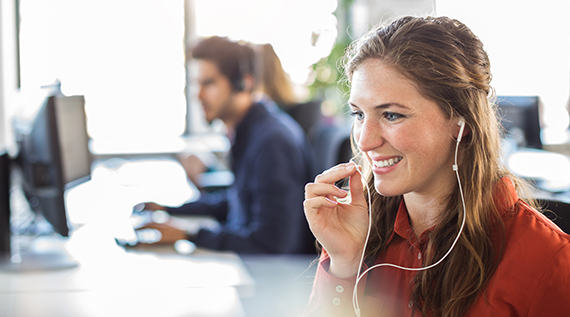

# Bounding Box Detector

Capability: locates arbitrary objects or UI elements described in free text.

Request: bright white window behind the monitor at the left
[20,0,186,140]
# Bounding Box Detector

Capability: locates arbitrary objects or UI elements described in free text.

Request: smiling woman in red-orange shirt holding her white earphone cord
[304,17,570,316]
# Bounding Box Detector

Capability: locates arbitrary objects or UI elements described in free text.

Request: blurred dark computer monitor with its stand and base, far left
[0,94,91,270]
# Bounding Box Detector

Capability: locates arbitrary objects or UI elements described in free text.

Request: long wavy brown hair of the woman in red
[342,17,527,316]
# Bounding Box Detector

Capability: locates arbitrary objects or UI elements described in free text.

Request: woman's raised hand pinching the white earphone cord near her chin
[303,163,368,278]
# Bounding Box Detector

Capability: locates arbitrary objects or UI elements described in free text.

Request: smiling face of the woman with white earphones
[349,59,459,197]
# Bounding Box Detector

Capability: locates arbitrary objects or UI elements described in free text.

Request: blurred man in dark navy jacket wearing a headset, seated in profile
[138,37,315,253]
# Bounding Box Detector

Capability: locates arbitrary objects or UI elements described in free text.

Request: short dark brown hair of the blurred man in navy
[190,36,256,91]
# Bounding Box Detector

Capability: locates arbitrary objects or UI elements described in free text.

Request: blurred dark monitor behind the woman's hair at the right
[497,96,542,149]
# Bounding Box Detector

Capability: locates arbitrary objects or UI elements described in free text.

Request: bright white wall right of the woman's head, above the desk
[436,0,570,143]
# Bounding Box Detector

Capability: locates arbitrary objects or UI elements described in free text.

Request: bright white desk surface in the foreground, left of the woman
[0,232,316,317]
